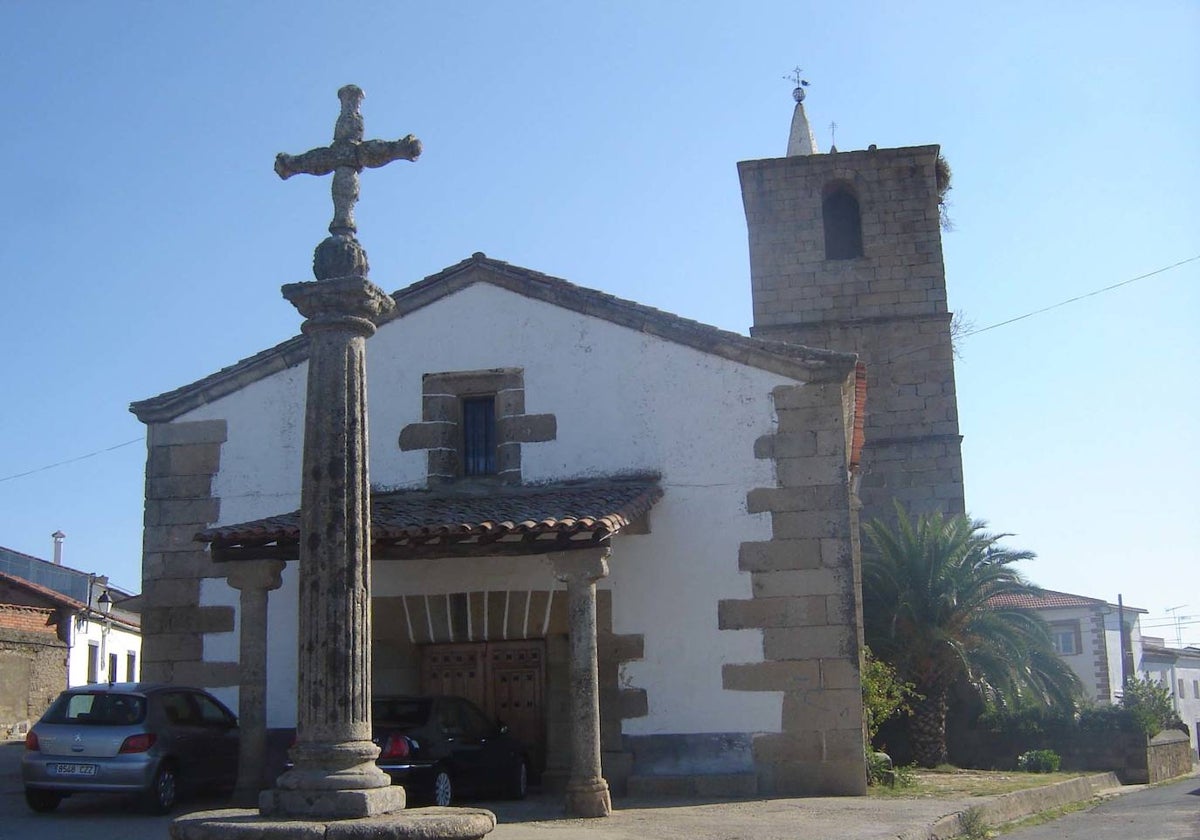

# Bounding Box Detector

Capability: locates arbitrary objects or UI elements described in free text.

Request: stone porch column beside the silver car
[226,560,284,805]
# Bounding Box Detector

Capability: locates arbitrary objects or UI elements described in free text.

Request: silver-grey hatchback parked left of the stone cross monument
[20,683,238,814]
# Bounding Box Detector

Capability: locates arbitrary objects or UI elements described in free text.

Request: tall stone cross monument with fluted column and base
[259,85,412,818]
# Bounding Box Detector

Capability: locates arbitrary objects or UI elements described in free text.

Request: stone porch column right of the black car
[550,547,612,817]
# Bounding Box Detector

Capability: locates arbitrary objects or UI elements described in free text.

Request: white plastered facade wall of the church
[180,284,797,734]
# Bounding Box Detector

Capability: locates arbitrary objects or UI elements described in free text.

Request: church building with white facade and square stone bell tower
[132,90,964,797]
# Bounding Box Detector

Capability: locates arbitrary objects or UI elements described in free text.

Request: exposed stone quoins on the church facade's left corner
[142,420,238,688]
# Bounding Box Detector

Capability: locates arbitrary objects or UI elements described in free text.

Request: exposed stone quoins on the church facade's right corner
[719,380,866,796]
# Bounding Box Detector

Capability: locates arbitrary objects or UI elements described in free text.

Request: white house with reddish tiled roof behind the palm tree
[990,589,1146,704]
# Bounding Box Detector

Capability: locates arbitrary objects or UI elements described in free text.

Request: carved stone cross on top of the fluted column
[275,84,421,242]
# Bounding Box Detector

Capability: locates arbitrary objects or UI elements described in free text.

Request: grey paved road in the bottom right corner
[1007,776,1200,840]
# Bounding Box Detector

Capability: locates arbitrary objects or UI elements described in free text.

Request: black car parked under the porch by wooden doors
[371,696,529,805]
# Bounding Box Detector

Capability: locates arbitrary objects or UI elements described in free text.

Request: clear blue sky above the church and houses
[0,0,1200,643]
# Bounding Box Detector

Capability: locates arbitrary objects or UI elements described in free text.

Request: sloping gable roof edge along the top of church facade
[130,253,856,424]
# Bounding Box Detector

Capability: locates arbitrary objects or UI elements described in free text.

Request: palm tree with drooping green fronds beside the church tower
[863,504,1080,767]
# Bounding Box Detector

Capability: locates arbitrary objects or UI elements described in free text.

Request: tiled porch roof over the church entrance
[196,475,662,560]
